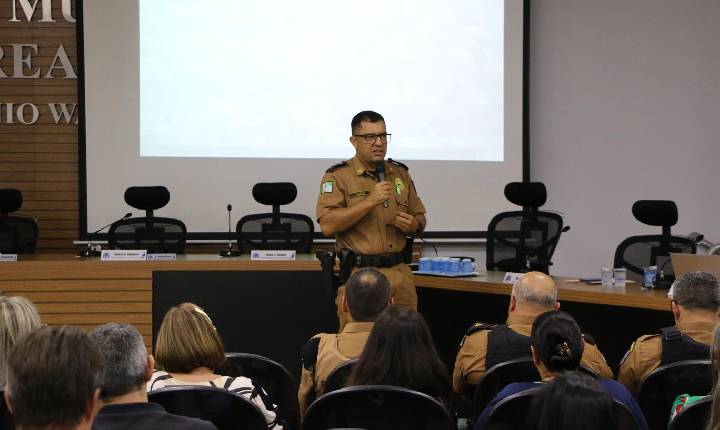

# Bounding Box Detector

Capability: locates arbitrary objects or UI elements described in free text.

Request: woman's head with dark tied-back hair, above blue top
[530,311,585,372]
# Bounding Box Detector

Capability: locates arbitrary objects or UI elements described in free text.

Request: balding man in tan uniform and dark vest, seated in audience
[453,272,613,394]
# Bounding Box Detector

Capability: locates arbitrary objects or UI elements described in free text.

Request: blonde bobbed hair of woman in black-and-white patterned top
[155,303,225,373]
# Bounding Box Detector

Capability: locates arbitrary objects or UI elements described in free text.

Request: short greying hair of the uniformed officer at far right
[673,272,720,311]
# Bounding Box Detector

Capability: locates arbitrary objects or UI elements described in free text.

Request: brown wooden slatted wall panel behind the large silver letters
[0,0,79,252]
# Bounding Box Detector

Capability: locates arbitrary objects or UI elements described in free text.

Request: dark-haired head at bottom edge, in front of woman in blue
[527,372,617,430]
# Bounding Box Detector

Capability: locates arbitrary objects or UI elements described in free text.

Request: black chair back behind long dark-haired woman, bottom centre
[302,385,456,430]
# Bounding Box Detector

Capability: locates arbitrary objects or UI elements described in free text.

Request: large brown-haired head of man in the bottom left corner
[5,326,103,429]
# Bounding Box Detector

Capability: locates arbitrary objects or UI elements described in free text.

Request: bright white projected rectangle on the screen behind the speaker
[139,0,505,162]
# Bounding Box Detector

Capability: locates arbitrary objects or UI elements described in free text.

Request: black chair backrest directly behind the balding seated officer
[473,358,540,417]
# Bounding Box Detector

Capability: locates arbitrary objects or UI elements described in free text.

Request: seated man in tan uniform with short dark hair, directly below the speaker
[298,267,392,413]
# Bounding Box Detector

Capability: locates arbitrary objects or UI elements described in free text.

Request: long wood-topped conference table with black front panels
[0,254,672,375]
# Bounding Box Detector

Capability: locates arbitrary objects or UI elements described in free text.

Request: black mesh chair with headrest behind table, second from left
[108,186,187,254]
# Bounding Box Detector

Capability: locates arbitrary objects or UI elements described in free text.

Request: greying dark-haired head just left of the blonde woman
[90,324,147,400]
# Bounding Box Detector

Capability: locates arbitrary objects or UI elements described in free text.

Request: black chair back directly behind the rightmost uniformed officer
[636,360,712,429]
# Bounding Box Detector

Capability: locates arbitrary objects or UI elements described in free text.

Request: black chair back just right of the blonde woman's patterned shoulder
[217,352,300,430]
